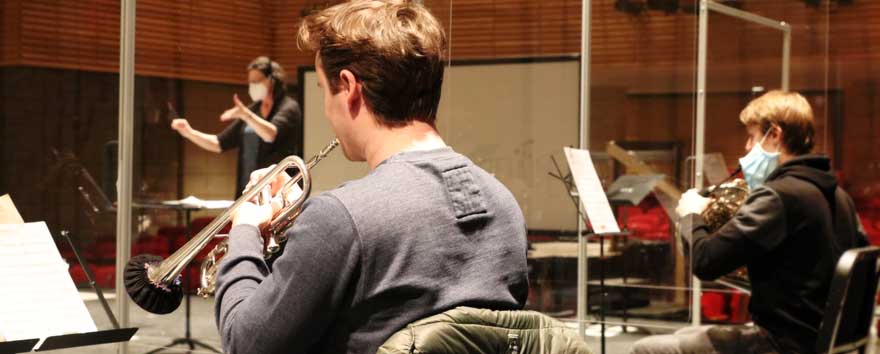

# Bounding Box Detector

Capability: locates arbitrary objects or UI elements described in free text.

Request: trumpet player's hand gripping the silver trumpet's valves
[232,165,302,230]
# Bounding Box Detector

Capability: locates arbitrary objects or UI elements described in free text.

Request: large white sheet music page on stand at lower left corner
[0,222,97,340]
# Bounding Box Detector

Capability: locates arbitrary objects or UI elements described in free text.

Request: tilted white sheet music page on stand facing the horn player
[565,147,620,234]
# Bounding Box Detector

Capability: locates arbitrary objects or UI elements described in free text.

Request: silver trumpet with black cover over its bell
[124,139,339,314]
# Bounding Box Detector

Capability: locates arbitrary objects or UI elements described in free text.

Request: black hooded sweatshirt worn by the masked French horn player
[682,155,868,353]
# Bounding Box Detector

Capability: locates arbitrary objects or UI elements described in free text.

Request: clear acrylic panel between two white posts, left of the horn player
[588,1,698,340]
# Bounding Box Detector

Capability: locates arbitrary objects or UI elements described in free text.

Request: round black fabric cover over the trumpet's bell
[124,254,183,315]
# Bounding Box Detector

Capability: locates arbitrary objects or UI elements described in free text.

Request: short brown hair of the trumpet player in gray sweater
[298,0,446,126]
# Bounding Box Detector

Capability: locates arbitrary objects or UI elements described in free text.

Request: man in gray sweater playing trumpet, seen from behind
[216,0,528,354]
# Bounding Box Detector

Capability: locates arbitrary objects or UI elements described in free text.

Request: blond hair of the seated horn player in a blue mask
[739,90,814,155]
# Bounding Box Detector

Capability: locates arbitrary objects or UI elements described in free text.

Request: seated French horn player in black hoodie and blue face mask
[632,91,867,353]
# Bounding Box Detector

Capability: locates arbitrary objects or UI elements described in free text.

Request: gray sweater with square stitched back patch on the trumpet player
[216,148,528,354]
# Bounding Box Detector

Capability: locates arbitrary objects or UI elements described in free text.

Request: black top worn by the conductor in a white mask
[217,96,303,198]
